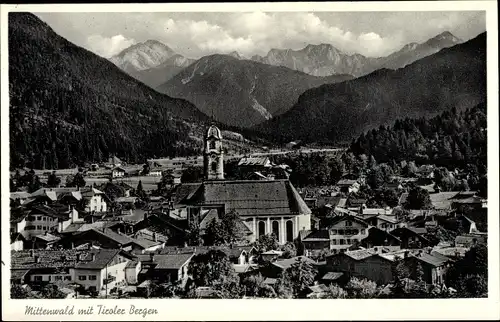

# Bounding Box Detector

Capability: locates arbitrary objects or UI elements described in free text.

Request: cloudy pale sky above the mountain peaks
[35,11,486,59]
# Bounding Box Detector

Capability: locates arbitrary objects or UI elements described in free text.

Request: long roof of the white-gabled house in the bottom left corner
[11,249,124,269]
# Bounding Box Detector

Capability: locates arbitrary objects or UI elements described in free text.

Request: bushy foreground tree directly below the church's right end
[283,257,317,298]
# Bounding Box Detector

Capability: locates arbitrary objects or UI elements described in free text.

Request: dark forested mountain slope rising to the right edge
[254,33,486,143]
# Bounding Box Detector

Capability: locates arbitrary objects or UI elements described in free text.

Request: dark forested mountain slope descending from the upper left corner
[8,13,209,169]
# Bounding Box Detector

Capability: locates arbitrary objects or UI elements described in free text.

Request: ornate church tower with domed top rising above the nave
[203,125,224,180]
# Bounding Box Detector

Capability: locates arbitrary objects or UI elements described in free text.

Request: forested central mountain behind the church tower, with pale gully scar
[157,54,353,127]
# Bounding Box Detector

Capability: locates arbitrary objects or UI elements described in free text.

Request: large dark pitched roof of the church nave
[185,180,311,216]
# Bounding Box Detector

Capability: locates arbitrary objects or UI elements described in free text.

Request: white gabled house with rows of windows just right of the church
[328,215,370,252]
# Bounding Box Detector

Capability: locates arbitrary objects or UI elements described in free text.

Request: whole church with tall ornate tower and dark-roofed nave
[179,125,311,244]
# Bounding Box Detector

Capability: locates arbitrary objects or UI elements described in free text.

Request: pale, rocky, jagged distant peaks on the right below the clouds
[252,31,462,77]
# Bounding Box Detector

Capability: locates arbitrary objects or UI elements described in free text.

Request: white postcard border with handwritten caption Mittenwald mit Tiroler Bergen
[0,1,500,321]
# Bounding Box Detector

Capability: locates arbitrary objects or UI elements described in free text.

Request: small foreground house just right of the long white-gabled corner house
[138,252,194,285]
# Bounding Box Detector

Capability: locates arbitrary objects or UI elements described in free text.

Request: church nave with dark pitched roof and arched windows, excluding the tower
[182,180,311,243]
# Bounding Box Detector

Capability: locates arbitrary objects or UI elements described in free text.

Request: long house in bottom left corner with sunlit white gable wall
[11,249,134,293]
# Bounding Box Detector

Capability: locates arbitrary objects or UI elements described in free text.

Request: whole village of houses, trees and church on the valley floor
[10,126,487,298]
